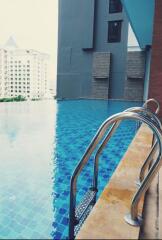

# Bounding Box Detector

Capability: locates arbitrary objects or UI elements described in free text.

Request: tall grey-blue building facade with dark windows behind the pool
[57,0,128,99]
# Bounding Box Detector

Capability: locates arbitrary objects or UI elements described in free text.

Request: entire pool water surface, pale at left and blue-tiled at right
[0,100,140,239]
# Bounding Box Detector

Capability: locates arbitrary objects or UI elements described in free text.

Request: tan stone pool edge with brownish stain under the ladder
[76,125,154,239]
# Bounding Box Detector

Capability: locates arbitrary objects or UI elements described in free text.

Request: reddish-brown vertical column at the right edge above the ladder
[149,0,162,119]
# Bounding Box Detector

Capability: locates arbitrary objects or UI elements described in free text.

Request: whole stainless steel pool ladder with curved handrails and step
[69,99,162,239]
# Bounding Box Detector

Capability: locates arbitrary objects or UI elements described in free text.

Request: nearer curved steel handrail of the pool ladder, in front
[69,112,161,239]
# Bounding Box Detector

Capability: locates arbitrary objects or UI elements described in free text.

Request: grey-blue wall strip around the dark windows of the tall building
[94,0,128,99]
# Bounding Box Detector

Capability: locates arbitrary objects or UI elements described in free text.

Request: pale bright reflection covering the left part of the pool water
[0,101,56,239]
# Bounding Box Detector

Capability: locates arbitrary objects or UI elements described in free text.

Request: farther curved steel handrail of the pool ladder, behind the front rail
[93,107,161,193]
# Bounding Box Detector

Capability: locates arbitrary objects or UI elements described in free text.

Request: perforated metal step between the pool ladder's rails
[75,189,97,222]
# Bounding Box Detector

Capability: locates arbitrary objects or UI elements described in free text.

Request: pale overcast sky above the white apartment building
[0,0,58,90]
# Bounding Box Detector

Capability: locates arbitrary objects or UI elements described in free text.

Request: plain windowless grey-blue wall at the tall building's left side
[57,0,95,98]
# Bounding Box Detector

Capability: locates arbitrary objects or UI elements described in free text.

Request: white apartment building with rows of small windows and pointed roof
[0,38,49,99]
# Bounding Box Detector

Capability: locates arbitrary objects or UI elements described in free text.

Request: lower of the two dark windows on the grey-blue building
[108,20,122,43]
